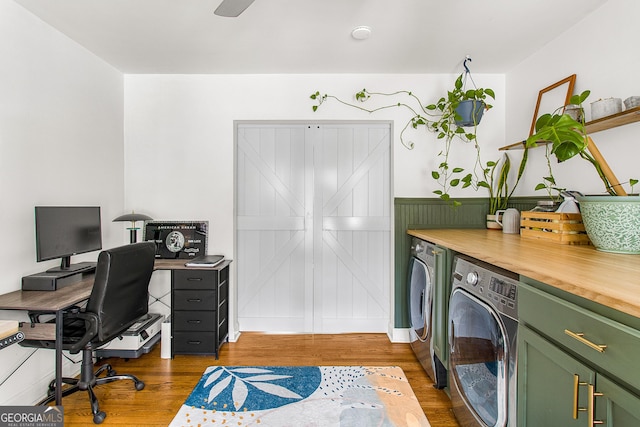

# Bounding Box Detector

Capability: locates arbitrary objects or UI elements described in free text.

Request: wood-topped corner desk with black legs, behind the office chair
[0,259,231,405]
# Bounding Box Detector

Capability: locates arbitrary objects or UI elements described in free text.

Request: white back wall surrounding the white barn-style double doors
[125,75,505,204]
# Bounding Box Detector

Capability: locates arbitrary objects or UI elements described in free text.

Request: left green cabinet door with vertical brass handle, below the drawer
[518,325,595,427]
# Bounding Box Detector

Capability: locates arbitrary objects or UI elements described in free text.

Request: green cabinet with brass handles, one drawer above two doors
[518,283,640,427]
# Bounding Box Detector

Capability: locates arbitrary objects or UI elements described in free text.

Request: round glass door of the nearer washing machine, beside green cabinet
[449,288,508,427]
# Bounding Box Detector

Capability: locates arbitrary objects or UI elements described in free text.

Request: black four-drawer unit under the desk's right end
[171,261,230,359]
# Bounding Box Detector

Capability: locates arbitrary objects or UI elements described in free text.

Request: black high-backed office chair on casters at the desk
[21,242,156,424]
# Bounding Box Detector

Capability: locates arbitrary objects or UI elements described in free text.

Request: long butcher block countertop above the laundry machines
[407,229,640,318]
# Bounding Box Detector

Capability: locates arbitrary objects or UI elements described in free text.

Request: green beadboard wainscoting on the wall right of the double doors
[394,197,538,328]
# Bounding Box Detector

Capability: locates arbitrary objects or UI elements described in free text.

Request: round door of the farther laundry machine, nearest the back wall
[408,257,433,341]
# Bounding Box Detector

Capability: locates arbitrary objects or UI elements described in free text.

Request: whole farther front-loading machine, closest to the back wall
[407,237,447,388]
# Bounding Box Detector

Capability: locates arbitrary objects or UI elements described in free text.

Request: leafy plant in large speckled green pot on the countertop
[525,90,640,254]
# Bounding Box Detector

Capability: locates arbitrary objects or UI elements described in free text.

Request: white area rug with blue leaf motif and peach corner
[170,366,430,427]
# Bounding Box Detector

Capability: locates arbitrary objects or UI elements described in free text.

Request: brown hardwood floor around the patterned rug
[53,332,458,427]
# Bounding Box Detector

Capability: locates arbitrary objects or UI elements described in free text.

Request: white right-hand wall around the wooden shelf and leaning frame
[506,0,640,197]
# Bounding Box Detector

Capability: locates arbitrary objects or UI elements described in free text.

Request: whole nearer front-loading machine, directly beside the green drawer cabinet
[449,255,518,427]
